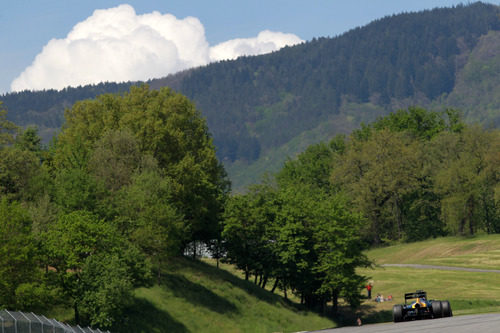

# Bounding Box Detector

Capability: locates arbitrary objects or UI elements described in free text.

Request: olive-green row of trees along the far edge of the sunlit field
[336,107,500,240]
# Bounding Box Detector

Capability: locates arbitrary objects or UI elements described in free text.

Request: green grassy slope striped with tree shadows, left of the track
[112,259,336,333]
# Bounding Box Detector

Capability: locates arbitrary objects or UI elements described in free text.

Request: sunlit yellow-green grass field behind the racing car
[359,235,500,322]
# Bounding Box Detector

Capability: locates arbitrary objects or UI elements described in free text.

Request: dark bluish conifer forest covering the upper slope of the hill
[157,2,500,161]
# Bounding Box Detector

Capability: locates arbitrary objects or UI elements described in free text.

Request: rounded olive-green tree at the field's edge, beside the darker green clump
[332,129,421,243]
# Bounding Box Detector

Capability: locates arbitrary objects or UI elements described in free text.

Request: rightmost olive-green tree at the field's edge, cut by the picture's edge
[436,127,500,235]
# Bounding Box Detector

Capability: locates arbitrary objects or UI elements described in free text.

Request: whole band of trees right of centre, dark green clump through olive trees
[222,107,500,311]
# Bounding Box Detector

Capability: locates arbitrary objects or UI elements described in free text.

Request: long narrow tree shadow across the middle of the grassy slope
[161,274,238,313]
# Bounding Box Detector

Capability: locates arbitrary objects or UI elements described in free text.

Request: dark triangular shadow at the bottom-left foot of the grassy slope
[111,298,189,333]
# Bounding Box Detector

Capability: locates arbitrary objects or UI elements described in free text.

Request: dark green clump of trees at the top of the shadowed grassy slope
[222,147,369,311]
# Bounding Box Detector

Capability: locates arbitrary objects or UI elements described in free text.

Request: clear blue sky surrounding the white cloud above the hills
[0,0,494,93]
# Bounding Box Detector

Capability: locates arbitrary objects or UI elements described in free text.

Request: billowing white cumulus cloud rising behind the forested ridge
[11,5,302,91]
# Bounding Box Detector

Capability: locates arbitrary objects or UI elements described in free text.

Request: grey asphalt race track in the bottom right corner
[308,313,500,333]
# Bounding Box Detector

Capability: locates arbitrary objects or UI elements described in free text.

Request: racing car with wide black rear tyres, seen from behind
[392,290,453,323]
